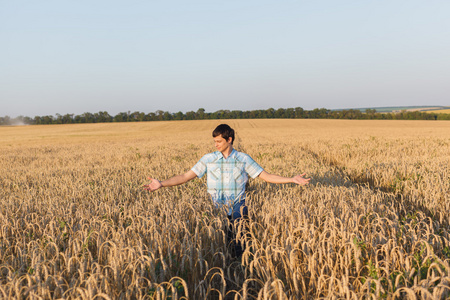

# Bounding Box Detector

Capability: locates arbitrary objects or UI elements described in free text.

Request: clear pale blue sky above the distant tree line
[0,0,450,117]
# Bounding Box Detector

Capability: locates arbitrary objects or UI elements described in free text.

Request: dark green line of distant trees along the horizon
[0,107,450,125]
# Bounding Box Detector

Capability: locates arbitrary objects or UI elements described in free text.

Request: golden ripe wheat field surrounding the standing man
[0,120,450,299]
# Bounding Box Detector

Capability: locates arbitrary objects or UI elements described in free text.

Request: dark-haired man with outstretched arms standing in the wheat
[144,124,311,255]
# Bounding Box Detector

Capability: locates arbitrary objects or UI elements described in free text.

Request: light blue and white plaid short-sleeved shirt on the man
[191,149,263,214]
